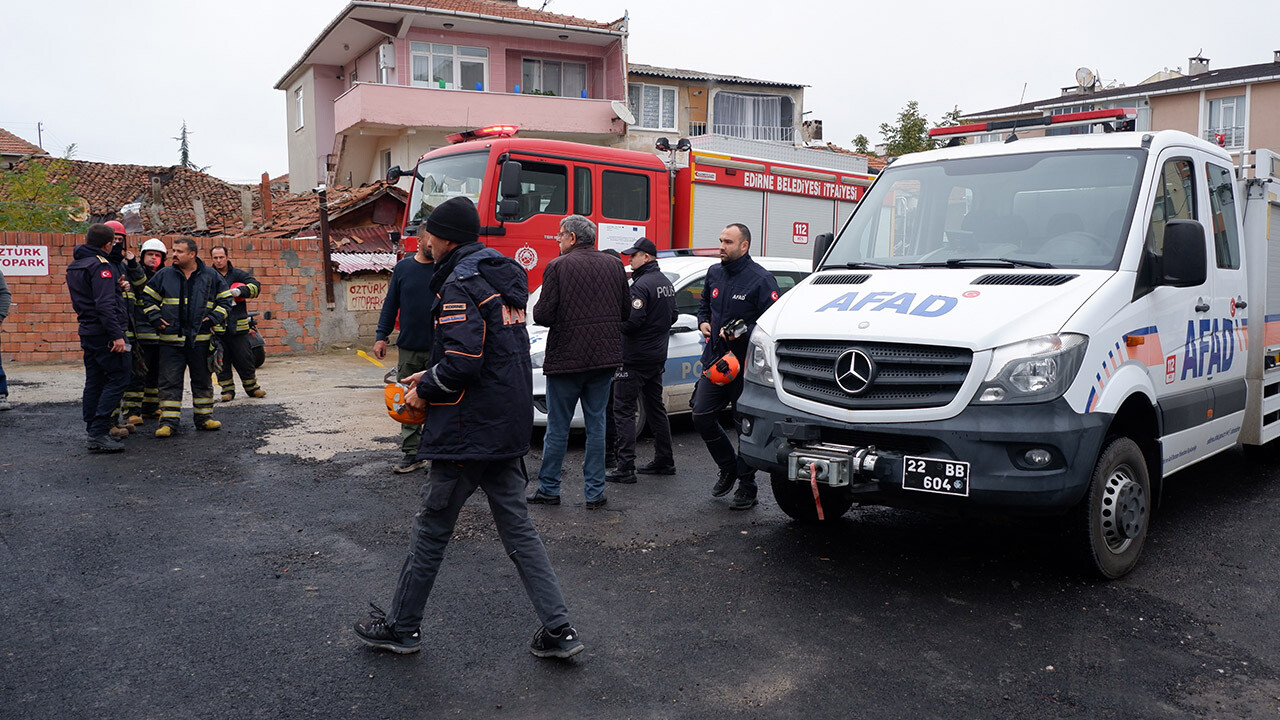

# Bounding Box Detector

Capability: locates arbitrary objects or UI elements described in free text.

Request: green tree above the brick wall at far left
[0,160,84,232]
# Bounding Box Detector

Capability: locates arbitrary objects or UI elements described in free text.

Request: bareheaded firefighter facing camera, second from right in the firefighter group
[143,237,232,437]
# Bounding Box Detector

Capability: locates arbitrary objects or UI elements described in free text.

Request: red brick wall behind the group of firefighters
[0,232,326,363]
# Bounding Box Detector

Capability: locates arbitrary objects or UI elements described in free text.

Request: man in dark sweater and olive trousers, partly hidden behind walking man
[374,224,435,474]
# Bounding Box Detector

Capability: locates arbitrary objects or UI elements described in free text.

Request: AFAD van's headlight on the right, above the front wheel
[974,333,1089,404]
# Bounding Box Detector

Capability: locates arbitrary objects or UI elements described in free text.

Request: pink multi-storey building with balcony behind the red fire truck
[275,0,627,192]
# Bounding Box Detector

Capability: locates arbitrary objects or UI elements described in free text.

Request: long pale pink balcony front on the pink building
[333,83,626,137]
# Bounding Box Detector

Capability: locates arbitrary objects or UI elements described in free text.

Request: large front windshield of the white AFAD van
[823,149,1146,269]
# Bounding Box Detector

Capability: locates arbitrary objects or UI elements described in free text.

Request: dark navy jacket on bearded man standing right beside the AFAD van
[698,254,778,368]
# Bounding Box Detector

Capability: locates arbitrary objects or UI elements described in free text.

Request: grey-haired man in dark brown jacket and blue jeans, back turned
[529,215,631,510]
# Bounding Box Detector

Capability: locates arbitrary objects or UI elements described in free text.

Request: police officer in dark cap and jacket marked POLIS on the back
[604,237,678,483]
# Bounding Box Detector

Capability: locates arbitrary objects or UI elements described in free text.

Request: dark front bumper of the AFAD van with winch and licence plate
[737,382,1111,512]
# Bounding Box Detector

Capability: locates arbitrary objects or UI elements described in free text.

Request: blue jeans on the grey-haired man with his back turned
[538,368,613,500]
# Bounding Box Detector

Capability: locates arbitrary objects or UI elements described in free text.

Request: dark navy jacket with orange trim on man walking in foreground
[417,242,534,461]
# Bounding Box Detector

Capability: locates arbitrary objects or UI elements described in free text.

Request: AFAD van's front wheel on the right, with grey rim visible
[1071,437,1151,580]
